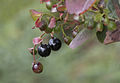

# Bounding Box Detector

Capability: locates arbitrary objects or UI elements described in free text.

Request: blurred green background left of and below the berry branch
[0,0,120,83]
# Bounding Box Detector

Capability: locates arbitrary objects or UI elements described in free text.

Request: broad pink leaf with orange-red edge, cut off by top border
[66,0,96,14]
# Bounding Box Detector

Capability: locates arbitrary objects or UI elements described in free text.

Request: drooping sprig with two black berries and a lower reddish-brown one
[29,37,62,73]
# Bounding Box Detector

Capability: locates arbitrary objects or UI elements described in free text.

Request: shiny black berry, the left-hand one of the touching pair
[38,44,51,57]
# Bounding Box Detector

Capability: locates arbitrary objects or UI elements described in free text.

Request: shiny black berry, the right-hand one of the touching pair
[48,38,62,51]
